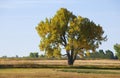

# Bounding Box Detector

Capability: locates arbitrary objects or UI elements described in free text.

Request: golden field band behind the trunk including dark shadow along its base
[0,59,120,69]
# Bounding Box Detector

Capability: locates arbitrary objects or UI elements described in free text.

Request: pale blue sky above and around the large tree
[0,0,120,56]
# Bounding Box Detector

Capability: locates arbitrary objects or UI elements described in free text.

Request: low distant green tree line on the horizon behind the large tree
[1,50,117,60]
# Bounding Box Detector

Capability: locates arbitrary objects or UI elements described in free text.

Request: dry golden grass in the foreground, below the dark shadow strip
[0,69,120,78]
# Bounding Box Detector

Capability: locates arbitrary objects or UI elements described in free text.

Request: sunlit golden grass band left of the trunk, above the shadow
[0,59,67,65]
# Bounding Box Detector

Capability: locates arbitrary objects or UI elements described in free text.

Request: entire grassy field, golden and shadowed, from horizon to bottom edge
[0,59,120,78]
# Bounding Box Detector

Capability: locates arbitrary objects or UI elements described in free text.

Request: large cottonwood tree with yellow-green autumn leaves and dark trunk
[36,8,106,65]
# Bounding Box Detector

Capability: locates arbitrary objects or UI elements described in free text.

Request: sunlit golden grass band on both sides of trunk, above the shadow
[0,59,120,65]
